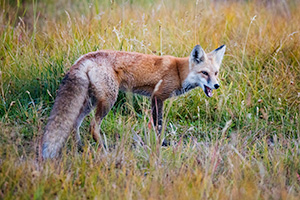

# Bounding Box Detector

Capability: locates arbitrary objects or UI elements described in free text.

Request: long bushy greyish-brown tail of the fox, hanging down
[42,71,89,159]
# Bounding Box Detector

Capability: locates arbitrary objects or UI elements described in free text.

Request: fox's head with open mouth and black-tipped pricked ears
[183,45,226,97]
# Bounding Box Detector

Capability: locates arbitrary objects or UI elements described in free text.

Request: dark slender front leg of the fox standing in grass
[151,96,164,135]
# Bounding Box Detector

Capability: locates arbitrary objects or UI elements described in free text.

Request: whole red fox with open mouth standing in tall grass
[41,45,226,159]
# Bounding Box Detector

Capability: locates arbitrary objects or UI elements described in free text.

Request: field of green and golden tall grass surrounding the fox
[0,0,300,200]
